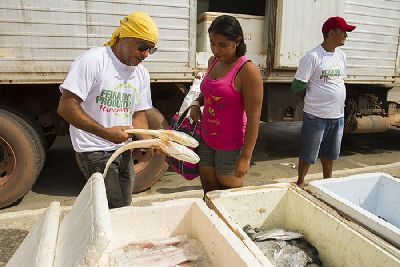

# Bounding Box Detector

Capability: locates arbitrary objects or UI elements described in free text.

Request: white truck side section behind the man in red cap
[274,0,400,86]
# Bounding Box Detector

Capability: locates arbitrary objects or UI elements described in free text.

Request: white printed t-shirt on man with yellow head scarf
[60,46,152,152]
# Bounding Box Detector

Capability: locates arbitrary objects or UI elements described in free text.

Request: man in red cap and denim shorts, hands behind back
[291,17,356,187]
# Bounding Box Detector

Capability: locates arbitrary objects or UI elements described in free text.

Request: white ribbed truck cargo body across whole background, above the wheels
[0,0,400,86]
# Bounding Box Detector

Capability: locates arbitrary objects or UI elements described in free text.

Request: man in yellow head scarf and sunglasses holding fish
[58,12,158,208]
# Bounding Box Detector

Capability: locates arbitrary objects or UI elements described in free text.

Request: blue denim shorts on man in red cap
[299,112,344,164]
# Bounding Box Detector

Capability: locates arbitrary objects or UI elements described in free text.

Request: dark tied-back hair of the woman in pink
[208,15,246,57]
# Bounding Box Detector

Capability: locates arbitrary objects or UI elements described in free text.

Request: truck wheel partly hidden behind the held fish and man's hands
[132,108,168,193]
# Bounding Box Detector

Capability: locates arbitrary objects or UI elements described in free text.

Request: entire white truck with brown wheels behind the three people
[0,0,400,207]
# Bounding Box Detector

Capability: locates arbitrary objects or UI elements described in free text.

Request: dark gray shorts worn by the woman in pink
[197,142,242,176]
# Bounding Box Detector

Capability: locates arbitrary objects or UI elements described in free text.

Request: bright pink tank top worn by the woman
[200,56,248,150]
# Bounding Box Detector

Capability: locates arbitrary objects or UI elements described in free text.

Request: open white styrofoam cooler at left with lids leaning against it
[9,173,261,267]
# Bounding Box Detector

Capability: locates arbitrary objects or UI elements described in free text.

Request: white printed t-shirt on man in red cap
[294,45,346,119]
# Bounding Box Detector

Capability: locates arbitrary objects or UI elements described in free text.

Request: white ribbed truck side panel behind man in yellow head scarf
[0,0,196,84]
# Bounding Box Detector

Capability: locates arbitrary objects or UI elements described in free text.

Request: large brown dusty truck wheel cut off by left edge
[0,106,46,208]
